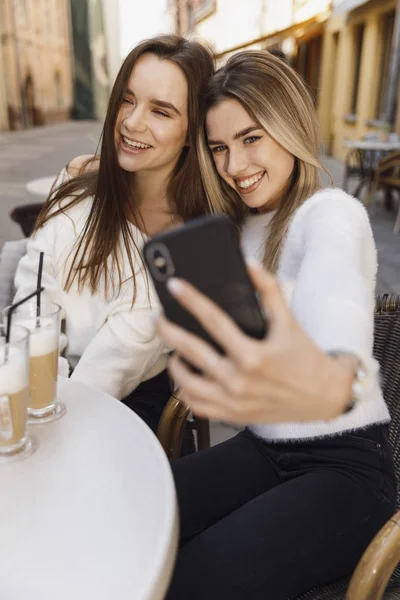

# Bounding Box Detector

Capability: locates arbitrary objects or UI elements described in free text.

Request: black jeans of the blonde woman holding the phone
[167,426,396,600]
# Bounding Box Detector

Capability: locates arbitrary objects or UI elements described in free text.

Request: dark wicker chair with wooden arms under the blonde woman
[159,294,400,600]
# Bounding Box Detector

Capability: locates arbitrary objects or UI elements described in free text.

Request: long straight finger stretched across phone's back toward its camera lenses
[168,278,259,364]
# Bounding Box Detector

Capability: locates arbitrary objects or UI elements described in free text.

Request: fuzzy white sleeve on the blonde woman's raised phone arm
[292,190,377,368]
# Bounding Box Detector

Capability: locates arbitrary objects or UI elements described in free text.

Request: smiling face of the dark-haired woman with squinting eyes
[115,54,188,177]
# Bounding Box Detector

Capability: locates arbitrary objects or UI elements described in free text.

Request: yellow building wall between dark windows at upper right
[318,0,400,160]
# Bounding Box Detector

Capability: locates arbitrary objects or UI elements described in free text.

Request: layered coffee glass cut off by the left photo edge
[0,325,37,463]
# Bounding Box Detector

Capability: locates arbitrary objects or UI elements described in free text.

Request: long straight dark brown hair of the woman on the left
[35,35,214,301]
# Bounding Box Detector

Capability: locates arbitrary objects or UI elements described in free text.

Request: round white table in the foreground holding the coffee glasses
[0,378,178,600]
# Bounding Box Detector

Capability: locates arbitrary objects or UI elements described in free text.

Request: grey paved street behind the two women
[0,121,400,294]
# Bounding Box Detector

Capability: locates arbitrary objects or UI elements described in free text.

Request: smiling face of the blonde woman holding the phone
[206,98,295,212]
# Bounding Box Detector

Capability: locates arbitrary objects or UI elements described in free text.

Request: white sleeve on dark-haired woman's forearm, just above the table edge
[71,308,165,399]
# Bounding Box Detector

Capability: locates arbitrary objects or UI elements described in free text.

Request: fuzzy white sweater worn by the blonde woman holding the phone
[242,189,389,440]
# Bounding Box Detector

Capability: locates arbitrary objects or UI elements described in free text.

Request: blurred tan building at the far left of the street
[0,0,73,129]
